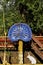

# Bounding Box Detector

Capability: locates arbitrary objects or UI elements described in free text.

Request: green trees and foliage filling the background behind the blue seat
[0,0,43,35]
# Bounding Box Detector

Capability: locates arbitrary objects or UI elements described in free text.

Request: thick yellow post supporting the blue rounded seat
[18,41,23,64]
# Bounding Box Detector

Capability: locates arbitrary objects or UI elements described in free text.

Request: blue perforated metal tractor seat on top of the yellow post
[8,23,32,42]
